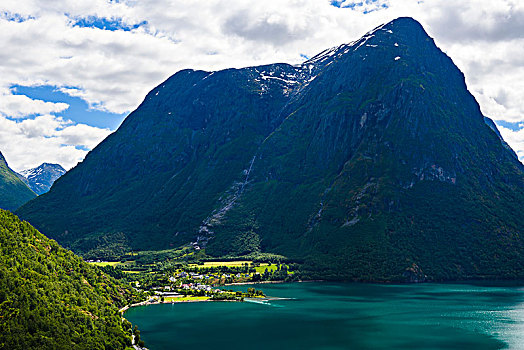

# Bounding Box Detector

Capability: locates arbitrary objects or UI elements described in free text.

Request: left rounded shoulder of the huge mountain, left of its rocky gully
[20,64,302,252]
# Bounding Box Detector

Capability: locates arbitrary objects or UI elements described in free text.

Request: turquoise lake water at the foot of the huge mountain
[125,283,524,350]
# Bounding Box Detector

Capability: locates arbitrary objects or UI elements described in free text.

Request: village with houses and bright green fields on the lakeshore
[89,260,296,305]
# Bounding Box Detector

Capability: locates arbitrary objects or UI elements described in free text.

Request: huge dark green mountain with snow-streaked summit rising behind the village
[18,18,524,280]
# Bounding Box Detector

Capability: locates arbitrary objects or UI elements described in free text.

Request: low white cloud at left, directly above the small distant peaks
[0,115,111,171]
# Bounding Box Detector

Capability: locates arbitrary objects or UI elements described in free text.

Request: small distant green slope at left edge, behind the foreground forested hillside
[0,152,36,210]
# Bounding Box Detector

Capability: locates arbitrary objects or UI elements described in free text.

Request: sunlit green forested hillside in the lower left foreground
[0,209,137,350]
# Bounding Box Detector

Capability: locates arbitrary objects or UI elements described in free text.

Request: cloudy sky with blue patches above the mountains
[0,0,524,171]
